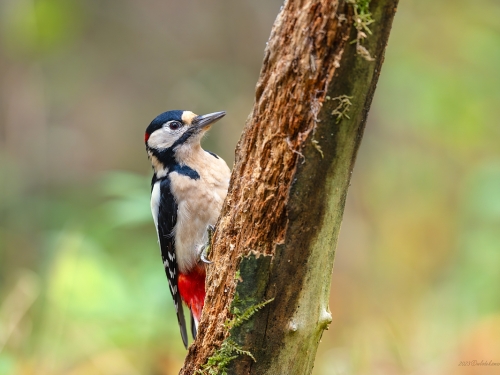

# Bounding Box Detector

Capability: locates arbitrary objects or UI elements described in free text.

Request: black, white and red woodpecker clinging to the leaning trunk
[144,110,231,349]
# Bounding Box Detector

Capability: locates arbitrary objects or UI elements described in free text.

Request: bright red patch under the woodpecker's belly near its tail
[177,266,206,321]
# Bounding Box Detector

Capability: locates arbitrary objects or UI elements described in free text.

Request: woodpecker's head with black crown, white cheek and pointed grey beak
[144,111,226,151]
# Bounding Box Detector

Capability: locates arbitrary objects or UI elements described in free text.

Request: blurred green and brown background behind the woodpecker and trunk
[0,0,500,375]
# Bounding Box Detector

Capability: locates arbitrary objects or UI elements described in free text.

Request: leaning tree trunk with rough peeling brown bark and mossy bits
[180,0,398,375]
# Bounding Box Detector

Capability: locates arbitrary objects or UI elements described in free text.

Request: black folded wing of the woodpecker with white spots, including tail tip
[158,178,188,349]
